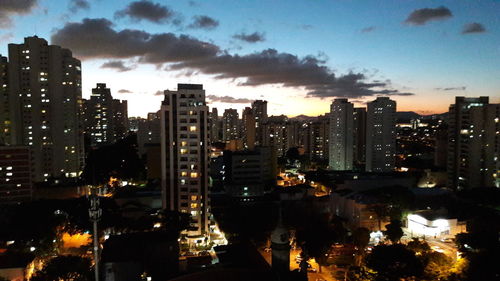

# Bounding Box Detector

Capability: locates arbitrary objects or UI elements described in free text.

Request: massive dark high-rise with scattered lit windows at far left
[0,36,84,181]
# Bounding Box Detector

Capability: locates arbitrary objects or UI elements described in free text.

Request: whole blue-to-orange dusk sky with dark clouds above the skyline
[0,0,500,116]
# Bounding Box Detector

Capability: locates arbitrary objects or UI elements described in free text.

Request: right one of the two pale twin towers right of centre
[366,97,396,172]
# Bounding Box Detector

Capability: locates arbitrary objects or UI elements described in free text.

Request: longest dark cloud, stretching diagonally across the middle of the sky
[51,19,410,98]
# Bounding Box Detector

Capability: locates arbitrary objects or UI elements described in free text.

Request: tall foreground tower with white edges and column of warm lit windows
[160,84,209,238]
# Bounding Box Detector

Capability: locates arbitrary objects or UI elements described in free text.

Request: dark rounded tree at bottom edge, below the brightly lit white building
[366,244,424,281]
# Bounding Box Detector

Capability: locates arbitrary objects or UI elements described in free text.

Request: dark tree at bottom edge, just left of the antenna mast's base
[31,256,93,281]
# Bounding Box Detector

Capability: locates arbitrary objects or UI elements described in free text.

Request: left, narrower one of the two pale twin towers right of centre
[329,99,354,168]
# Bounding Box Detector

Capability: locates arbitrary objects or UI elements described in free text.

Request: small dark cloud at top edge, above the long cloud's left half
[115,0,178,24]
